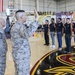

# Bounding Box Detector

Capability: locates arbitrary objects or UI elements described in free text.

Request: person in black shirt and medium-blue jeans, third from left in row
[56,18,64,51]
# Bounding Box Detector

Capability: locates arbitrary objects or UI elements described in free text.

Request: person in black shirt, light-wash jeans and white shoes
[49,18,55,48]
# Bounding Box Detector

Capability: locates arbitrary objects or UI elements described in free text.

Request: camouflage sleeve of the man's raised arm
[26,21,40,37]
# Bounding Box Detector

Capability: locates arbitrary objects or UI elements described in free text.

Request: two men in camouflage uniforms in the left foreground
[0,10,40,75]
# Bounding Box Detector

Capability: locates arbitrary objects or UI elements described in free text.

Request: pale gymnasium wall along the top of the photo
[1,0,75,14]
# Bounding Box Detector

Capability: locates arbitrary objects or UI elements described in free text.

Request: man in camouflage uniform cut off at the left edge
[0,18,7,75]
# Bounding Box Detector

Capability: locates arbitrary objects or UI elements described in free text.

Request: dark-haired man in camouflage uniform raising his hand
[11,10,39,75]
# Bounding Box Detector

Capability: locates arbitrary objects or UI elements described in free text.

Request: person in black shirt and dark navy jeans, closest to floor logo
[64,18,72,53]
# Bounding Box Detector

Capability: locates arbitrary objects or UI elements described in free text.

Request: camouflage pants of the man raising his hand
[13,50,30,75]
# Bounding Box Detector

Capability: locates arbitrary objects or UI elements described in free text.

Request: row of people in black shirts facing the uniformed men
[43,18,75,53]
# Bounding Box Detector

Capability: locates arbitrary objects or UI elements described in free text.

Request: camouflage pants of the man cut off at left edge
[0,52,6,75]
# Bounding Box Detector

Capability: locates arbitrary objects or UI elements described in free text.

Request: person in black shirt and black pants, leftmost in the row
[43,20,49,46]
